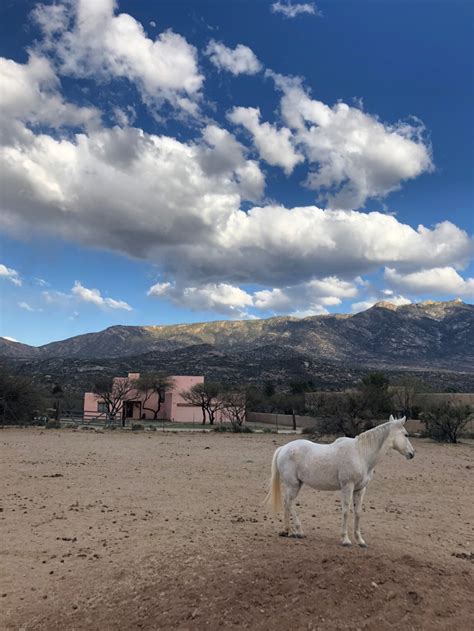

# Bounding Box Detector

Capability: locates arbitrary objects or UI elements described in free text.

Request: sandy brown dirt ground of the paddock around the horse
[0,429,474,631]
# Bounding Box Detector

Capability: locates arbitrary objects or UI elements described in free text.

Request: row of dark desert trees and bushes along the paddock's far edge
[0,370,471,442]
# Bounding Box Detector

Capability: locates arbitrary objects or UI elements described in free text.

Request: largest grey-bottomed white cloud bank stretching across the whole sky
[0,110,473,287]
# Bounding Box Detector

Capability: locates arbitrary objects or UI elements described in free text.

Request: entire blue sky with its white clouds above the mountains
[0,0,474,345]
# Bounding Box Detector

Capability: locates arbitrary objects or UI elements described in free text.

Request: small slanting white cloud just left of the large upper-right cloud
[227,107,304,175]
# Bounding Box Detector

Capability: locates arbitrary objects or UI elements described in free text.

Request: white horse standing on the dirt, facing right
[265,416,415,548]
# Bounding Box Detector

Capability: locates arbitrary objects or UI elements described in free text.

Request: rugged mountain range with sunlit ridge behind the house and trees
[0,300,474,390]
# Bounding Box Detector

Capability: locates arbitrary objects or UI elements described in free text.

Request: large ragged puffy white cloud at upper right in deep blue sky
[267,71,433,209]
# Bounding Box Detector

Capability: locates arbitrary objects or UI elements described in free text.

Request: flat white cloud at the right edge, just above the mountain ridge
[385,267,474,298]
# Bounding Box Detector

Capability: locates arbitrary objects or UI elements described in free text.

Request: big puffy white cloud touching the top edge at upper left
[34,0,204,114]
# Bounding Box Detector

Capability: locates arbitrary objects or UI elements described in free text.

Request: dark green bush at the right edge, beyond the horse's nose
[420,402,471,443]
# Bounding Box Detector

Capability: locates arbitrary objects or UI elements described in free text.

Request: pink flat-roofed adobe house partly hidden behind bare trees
[84,373,221,423]
